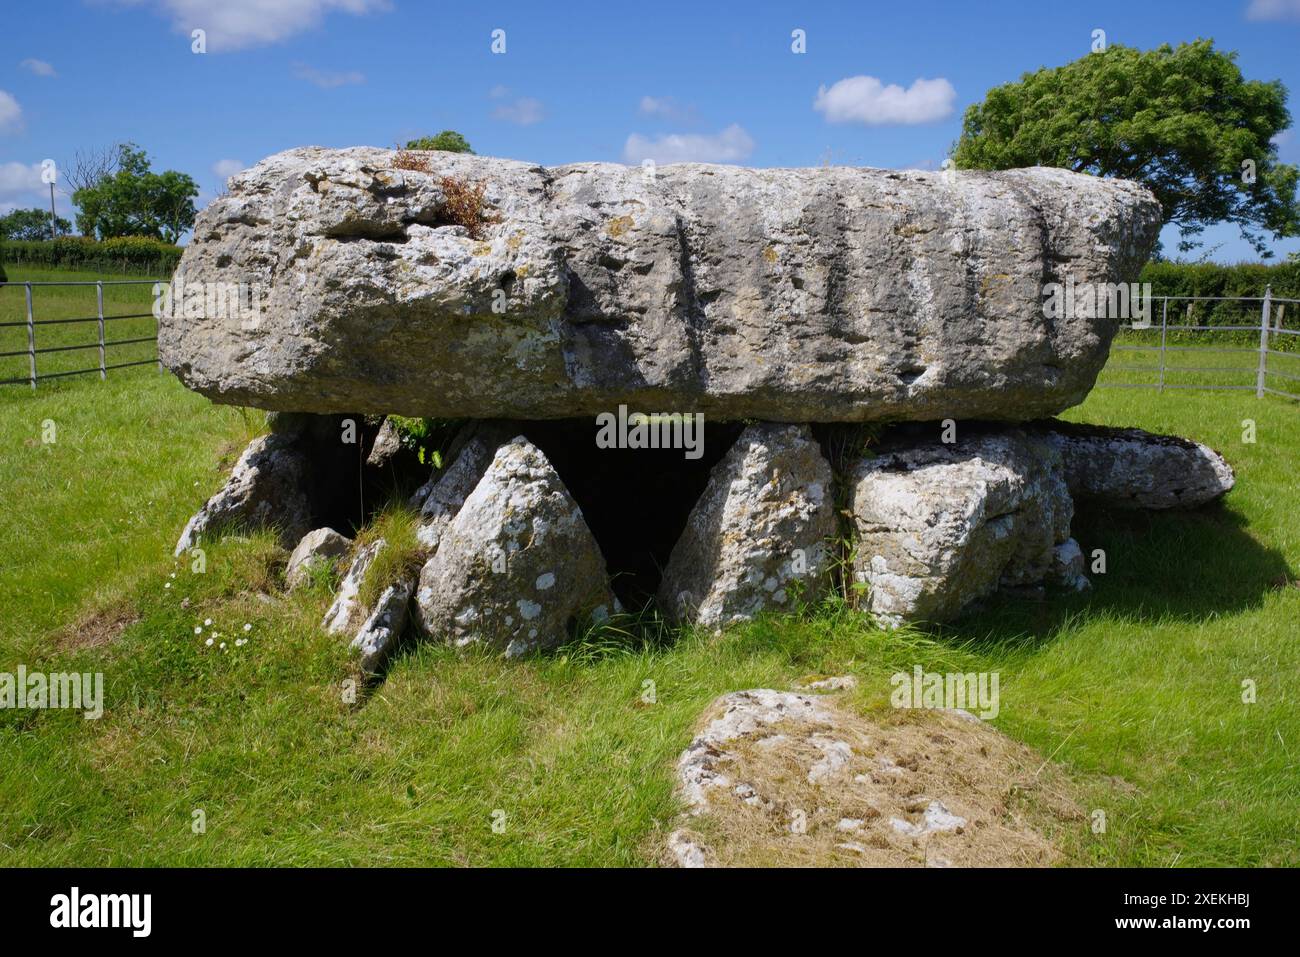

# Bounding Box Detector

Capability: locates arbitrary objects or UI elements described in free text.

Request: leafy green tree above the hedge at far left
[73,143,199,243]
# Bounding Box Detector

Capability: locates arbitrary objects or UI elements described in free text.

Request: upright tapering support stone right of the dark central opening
[659,424,836,628]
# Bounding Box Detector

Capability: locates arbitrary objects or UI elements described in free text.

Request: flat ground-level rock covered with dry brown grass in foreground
[664,677,1082,867]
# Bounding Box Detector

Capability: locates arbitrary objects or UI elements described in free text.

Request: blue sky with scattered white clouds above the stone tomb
[0,0,1300,261]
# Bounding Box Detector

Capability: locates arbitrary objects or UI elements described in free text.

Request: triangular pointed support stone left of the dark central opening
[415,436,616,657]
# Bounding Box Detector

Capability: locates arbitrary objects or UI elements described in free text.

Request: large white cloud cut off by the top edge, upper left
[118,0,391,53]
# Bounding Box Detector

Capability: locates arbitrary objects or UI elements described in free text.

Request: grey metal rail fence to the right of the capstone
[1097,287,1300,400]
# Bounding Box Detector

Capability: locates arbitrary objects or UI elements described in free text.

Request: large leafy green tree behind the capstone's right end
[953,40,1300,257]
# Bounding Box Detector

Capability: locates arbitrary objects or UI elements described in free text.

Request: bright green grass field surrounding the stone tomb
[0,269,1300,866]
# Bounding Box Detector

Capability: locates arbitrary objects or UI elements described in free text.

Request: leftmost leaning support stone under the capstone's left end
[174,432,312,555]
